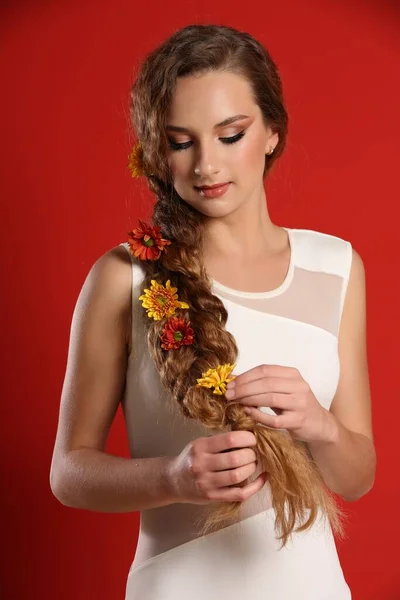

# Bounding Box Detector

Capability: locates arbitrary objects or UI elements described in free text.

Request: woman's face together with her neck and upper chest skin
[167,73,289,291]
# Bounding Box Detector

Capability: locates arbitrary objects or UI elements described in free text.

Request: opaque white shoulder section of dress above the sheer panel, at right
[292,229,358,279]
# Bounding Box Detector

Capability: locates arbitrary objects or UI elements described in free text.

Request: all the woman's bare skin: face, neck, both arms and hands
[50,73,375,512]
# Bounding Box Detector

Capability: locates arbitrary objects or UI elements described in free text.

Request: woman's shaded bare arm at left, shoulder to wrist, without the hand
[50,247,175,512]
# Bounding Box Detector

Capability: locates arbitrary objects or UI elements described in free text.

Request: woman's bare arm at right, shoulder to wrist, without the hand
[308,250,376,502]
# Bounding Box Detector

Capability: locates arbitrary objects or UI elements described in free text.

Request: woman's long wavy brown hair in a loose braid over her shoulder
[130,25,344,546]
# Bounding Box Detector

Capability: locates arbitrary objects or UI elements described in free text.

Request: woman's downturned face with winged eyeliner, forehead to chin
[167,72,278,217]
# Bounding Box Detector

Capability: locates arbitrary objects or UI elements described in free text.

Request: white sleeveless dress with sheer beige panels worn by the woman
[121,227,352,600]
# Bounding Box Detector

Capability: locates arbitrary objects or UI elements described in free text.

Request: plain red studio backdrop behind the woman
[0,0,400,600]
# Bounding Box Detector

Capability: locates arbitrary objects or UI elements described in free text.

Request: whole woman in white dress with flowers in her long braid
[51,25,375,600]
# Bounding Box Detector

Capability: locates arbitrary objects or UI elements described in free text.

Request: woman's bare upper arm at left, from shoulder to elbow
[52,247,132,474]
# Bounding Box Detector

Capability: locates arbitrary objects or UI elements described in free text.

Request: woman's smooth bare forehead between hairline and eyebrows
[167,72,258,130]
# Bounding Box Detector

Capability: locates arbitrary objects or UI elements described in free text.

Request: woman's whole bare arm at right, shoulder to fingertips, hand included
[226,250,376,501]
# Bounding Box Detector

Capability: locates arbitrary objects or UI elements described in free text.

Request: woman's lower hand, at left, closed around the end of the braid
[167,431,268,504]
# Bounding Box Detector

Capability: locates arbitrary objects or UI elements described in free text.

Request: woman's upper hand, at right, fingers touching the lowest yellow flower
[225,365,335,442]
